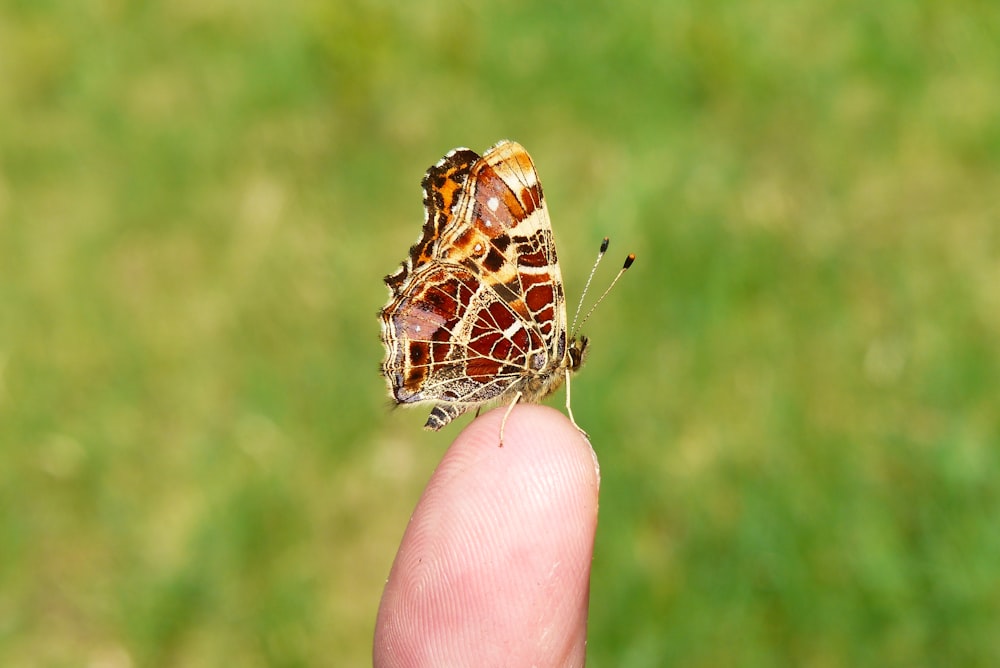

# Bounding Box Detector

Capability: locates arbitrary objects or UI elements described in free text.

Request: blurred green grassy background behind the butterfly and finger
[0,0,1000,667]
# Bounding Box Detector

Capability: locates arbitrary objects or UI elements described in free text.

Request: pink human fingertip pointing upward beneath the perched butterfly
[373,404,600,668]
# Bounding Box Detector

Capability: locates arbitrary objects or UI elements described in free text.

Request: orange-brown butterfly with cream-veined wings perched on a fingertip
[379,140,635,446]
